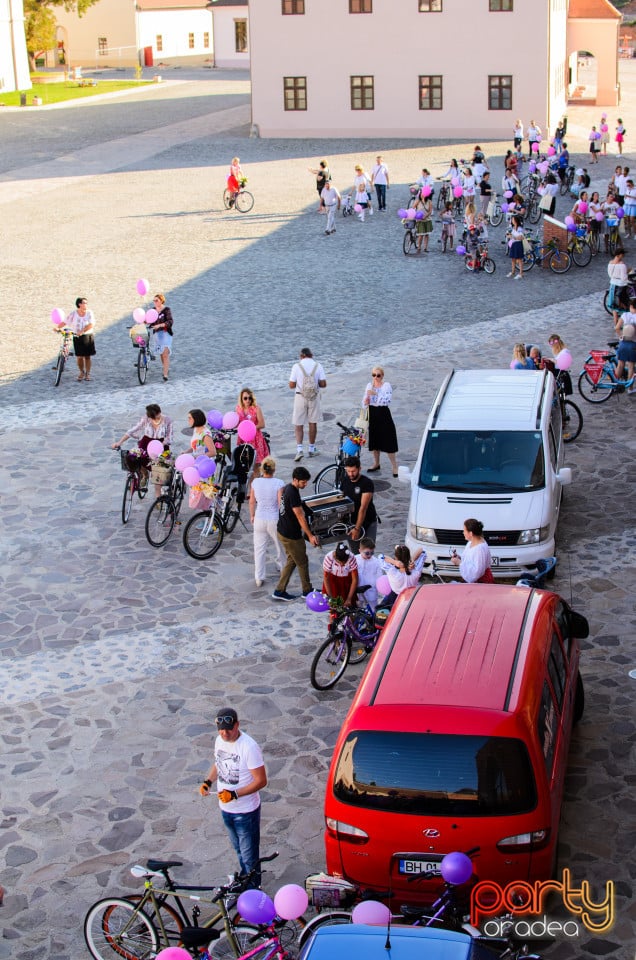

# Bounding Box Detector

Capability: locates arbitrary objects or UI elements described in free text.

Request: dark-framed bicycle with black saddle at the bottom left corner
[84,853,290,960]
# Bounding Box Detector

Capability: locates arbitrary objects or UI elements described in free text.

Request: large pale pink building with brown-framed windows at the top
[250,0,617,139]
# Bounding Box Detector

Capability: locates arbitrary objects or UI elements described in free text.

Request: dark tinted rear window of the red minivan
[333,730,537,817]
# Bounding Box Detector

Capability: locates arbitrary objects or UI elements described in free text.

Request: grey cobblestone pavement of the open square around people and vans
[0,69,636,960]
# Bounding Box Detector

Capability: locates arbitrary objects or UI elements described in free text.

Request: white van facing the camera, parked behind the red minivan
[406,370,572,577]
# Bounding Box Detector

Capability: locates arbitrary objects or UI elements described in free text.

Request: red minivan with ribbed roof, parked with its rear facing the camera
[325,584,588,902]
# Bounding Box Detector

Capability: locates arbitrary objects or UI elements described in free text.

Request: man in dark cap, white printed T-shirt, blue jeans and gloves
[199,707,267,887]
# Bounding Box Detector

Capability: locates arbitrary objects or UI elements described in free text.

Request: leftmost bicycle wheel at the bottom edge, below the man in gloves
[84,897,159,960]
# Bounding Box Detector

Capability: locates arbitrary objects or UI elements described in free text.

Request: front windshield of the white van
[419,430,545,493]
